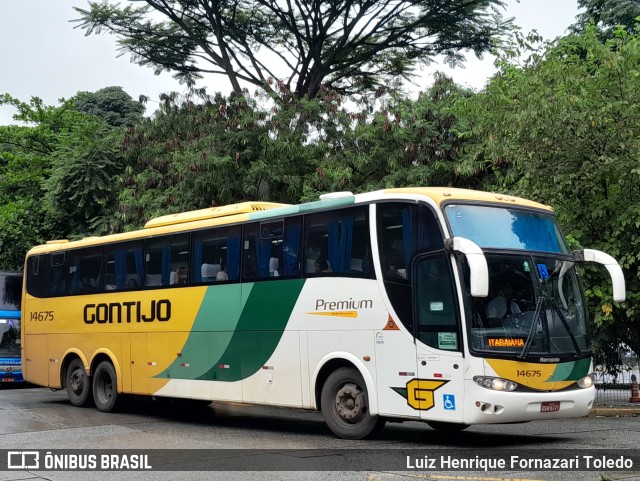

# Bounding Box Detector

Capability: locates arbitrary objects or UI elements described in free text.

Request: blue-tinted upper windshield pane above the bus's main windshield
[445,204,571,254]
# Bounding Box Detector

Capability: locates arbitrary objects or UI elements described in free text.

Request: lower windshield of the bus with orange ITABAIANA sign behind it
[467,254,589,358]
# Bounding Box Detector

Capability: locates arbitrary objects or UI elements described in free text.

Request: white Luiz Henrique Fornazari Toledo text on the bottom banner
[406,454,634,471]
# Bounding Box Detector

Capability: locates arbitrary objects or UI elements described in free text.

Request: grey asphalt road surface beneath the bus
[0,386,640,481]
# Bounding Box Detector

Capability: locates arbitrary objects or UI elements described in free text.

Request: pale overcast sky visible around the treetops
[0,0,578,125]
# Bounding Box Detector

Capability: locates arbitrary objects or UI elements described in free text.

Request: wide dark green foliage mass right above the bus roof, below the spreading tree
[111,75,490,230]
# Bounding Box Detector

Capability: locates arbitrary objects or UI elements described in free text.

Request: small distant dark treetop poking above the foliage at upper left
[71,87,144,127]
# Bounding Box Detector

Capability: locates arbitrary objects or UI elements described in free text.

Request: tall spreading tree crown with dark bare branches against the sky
[75,0,511,98]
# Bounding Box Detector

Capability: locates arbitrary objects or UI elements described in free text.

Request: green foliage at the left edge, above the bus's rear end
[0,94,126,268]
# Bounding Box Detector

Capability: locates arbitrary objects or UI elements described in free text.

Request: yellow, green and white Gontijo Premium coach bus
[22,188,625,439]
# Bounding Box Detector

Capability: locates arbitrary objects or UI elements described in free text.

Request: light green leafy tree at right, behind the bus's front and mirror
[458,26,640,334]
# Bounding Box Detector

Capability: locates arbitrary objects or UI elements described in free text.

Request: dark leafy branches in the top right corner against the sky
[573,0,640,37]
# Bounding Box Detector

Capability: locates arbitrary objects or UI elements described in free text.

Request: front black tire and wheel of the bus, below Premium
[320,367,385,439]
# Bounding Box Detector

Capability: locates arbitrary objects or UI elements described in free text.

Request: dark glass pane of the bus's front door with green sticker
[415,252,462,351]
